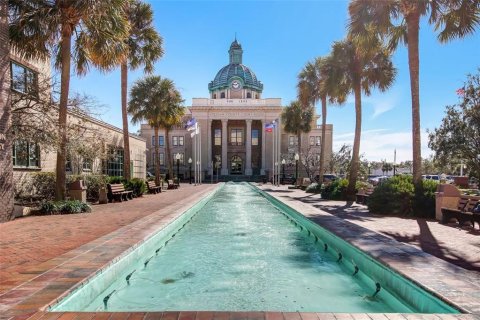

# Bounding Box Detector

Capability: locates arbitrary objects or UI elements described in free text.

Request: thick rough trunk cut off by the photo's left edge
[0,1,13,222]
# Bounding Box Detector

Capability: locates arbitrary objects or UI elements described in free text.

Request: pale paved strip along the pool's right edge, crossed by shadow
[260,186,480,319]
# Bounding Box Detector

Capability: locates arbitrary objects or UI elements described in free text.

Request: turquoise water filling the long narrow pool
[51,184,458,313]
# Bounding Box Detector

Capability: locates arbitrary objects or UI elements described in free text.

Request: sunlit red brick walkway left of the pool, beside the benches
[0,184,214,294]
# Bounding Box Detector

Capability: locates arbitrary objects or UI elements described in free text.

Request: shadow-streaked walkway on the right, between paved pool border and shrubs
[259,185,480,274]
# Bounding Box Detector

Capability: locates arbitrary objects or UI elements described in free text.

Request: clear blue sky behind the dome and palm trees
[71,0,480,161]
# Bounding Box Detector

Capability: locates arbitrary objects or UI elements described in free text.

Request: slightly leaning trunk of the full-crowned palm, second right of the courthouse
[347,79,362,201]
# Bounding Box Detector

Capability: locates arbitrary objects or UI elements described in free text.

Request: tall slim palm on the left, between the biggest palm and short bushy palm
[120,0,163,180]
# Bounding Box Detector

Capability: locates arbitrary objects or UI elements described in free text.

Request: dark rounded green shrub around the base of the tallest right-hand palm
[368,175,438,218]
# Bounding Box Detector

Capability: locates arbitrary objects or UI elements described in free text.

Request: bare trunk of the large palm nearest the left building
[55,25,72,200]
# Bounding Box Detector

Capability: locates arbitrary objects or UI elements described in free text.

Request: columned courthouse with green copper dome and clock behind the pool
[140,39,333,180]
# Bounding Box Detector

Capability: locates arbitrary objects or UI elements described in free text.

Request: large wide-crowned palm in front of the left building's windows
[8,0,129,200]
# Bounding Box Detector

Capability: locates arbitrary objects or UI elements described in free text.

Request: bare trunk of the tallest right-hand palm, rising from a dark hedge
[406,12,422,191]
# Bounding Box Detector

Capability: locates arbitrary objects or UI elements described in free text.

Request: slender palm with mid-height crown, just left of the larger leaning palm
[297,57,343,183]
